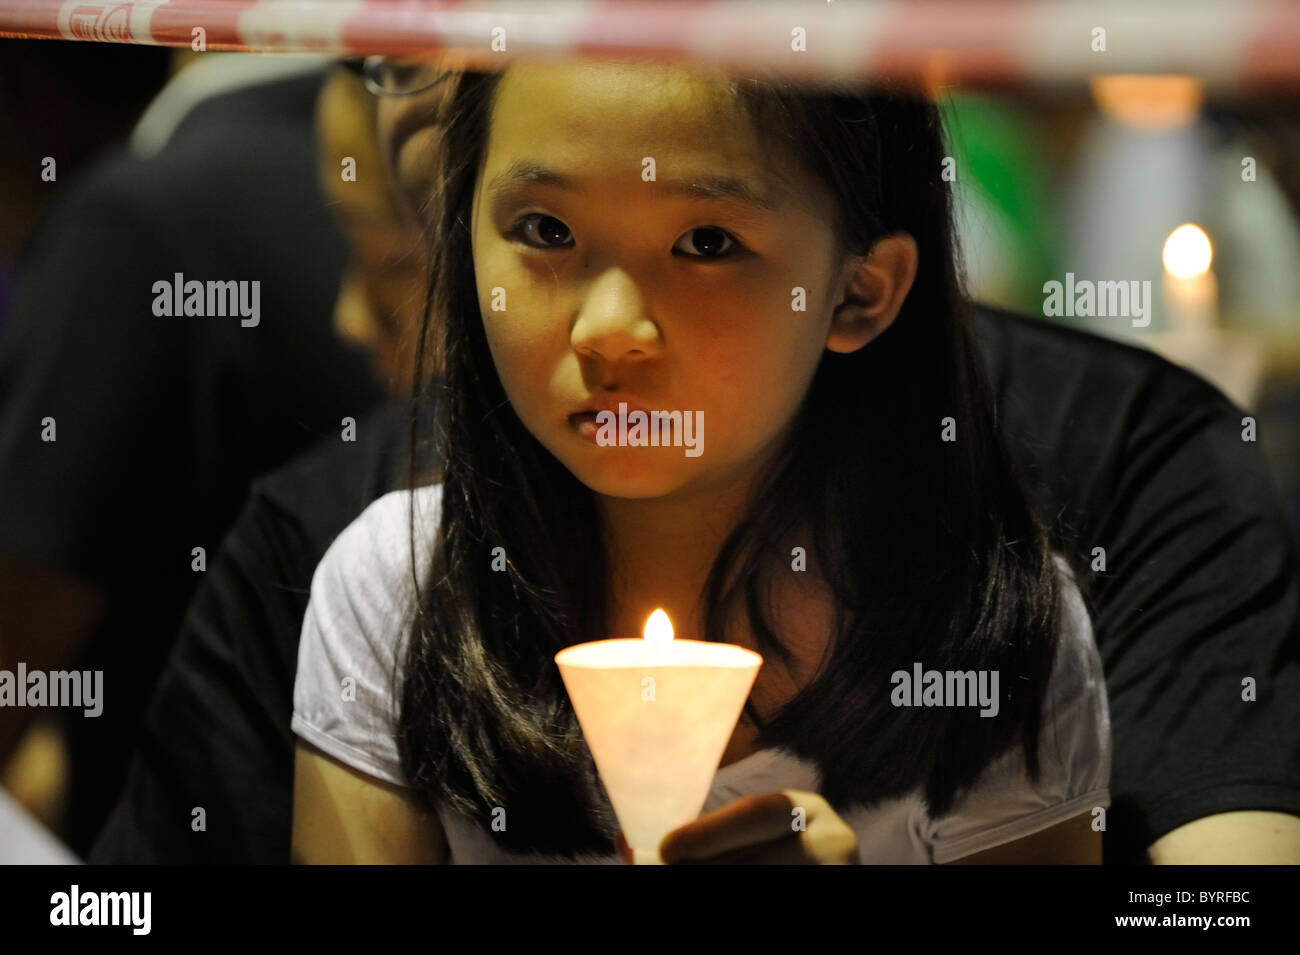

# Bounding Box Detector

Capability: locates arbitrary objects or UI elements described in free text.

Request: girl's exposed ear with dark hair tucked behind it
[826,233,919,355]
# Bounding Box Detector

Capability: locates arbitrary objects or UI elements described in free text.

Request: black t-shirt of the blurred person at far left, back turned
[0,71,382,854]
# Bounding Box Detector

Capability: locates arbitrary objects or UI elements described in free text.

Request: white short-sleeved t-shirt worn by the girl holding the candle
[293,485,1110,864]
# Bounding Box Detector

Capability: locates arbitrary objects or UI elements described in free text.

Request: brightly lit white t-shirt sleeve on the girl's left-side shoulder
[291,491,426,786]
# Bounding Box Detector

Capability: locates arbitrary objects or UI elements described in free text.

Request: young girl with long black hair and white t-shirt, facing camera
[293,61,1110,863]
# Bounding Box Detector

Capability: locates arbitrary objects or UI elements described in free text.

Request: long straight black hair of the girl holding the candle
[395,73,1058,858]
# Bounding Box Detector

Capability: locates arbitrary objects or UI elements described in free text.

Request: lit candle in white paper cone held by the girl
[555,611,763,864]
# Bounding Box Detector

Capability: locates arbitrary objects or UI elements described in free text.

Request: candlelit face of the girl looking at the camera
[472,61,849,498]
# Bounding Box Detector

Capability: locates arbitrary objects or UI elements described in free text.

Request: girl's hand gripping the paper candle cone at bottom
[618,789,859,865]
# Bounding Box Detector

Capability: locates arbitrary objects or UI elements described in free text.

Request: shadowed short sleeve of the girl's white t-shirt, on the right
[920,557,1110,864]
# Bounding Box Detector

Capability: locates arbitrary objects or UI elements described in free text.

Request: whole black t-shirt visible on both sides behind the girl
[91,309,1300,863]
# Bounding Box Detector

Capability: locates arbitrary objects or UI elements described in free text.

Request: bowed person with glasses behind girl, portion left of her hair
[90,64,447,864]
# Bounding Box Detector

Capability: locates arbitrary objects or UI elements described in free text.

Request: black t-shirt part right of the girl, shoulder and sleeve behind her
[979,312,1300,863]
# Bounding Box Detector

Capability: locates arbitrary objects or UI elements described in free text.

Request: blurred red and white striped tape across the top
[0,0,1300,87]
